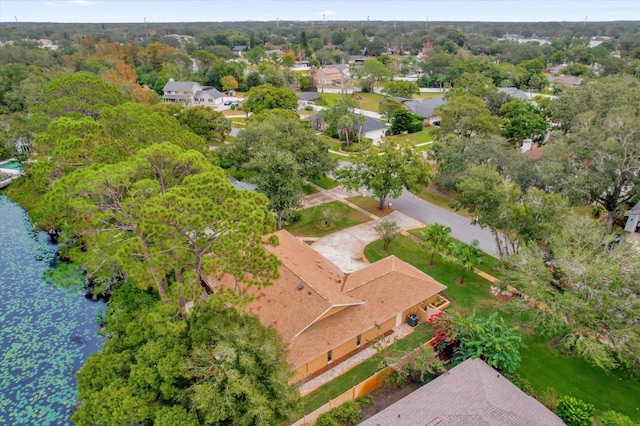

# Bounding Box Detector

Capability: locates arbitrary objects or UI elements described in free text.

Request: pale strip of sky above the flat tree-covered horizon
[0,0,640,23]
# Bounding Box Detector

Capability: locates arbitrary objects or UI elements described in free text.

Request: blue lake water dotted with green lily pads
[0,195,104,425]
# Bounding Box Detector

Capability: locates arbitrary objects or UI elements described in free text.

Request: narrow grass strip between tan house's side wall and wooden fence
[302,323,435,413]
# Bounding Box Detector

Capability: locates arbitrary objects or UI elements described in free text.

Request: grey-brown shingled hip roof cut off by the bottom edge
[360,359,564,426]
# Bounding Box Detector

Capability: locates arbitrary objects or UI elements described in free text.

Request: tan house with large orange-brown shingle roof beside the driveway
[209,230,446,382]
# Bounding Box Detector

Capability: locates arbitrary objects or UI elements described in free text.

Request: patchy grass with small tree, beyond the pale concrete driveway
[285,201,371,237]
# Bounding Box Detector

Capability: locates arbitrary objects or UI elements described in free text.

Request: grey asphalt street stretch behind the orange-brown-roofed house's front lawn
[390,191,498,256]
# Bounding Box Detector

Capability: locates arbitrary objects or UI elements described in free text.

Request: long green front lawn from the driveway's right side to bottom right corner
[364,235,640,421]
